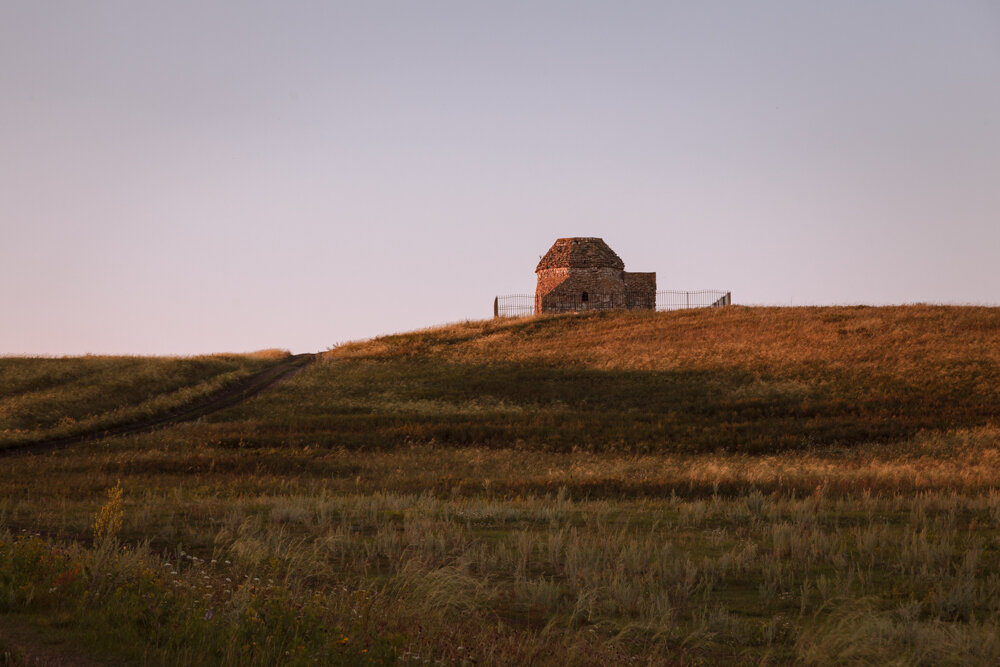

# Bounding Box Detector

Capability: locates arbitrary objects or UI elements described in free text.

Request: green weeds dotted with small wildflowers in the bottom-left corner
[0,534,392,665]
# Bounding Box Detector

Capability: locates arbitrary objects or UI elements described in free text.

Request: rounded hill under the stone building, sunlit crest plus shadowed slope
[212,305,1000,453]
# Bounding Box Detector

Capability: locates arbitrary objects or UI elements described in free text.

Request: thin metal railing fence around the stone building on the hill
[493,290,733,317]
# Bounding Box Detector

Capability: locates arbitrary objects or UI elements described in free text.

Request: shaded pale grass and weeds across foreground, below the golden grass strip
[0,472,1000,664]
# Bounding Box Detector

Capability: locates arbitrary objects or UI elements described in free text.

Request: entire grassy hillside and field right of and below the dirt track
[0,306,1000,665]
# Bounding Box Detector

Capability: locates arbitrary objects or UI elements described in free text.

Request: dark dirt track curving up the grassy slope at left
[0,354,319,457]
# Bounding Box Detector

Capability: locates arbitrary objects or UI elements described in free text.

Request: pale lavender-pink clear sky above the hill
[0,0,1000,354]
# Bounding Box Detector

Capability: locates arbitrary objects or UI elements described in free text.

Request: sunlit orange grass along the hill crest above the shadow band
[327,305,1000,376]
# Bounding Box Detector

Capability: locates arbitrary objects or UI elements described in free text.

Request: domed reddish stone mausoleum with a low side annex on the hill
[535,237,656,314]
